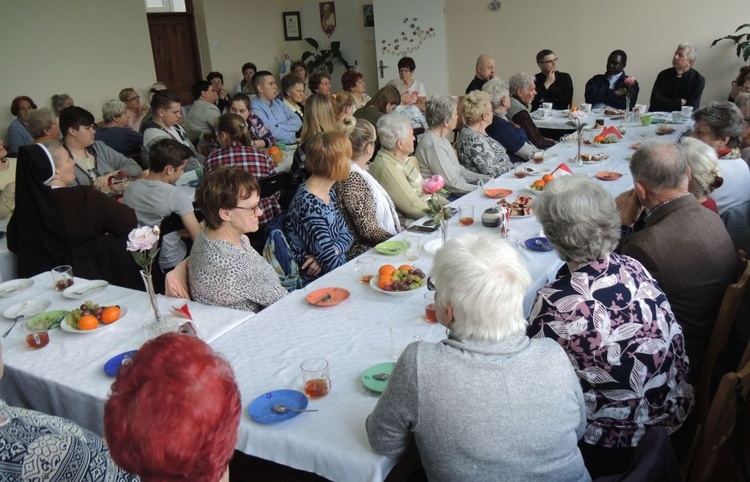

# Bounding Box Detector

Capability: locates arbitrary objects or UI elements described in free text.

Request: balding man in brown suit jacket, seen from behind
[616,142,737,370]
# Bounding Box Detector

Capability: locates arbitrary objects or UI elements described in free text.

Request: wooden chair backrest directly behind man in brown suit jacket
[695,250,750,425]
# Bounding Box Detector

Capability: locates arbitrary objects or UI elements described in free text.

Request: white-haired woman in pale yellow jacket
[370,114,446,226]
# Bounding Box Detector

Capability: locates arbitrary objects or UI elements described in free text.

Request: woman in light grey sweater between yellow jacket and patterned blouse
[414,95,493,197]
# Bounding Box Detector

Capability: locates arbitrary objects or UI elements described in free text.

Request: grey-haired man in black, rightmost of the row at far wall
[649,42,706,112]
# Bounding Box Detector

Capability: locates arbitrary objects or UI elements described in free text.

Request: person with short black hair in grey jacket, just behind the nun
[60,106,143,190]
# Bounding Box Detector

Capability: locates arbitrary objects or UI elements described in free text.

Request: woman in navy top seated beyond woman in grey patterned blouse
[482,77,537,163]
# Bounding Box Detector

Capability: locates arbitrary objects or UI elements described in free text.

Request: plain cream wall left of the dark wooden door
[0,0,155,135]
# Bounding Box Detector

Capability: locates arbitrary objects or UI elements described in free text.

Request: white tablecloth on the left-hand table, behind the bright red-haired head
[0,273,253,435]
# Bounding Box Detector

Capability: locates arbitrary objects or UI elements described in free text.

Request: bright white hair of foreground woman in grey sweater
[430,234,531,341]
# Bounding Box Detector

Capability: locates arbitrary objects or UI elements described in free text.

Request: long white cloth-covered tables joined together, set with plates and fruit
[0,121,676,482]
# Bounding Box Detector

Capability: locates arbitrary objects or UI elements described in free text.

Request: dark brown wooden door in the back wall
[147,8,202,105]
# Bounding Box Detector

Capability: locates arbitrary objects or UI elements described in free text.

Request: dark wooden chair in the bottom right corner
[681,354,750,482]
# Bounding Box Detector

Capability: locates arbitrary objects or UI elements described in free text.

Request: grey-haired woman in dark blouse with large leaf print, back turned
[528,176,693,478]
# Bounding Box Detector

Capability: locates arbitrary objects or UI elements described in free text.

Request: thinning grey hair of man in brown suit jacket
[632,141,688,190]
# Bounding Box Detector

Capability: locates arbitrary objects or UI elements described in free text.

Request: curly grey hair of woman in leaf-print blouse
[534,176,620,263]
